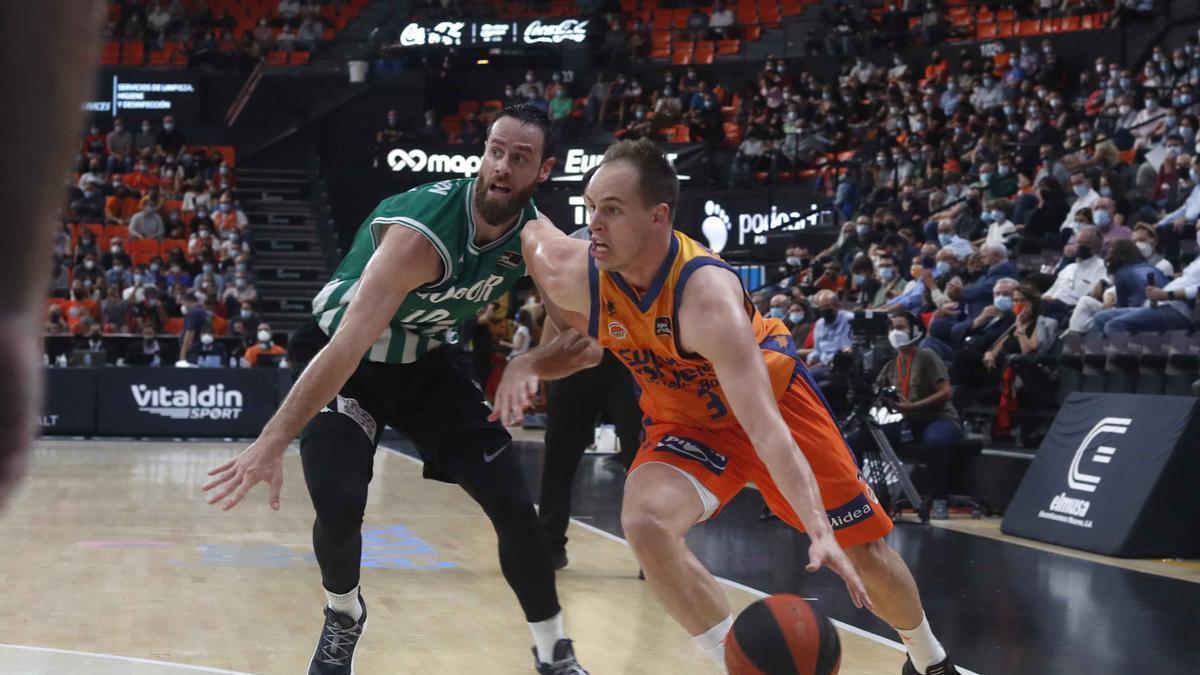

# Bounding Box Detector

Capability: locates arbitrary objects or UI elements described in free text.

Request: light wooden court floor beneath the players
[0,441,904,675]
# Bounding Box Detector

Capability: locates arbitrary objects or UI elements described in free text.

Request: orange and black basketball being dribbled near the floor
[725,593,841,675]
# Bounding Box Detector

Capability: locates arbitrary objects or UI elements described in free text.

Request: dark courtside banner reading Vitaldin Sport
[96,368,281,437]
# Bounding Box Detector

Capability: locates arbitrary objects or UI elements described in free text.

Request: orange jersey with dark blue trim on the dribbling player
[588,232,796,428]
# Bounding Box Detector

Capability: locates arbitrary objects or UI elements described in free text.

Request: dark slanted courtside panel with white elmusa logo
[1001,392,1200,557]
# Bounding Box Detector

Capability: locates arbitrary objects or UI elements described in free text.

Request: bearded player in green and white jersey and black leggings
[204,106,586,675]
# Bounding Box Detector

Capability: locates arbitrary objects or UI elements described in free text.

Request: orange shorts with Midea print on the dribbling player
[630,366,892,548]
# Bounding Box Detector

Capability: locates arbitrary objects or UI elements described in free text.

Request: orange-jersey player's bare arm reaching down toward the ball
[677,267,871,608]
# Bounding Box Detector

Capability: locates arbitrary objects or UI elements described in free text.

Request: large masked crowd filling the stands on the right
[689,38,1200,435]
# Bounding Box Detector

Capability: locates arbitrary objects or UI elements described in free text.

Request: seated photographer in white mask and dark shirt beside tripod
[846,311,962,520]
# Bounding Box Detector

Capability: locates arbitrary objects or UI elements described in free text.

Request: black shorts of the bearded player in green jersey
[295,321,512,483]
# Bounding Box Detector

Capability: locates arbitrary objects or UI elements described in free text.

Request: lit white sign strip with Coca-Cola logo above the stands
[398,19,588,47]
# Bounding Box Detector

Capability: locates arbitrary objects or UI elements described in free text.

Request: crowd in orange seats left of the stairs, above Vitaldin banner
[46,115,274,365]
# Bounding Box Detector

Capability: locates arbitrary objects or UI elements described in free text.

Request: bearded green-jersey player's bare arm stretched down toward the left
[204,227,442,510]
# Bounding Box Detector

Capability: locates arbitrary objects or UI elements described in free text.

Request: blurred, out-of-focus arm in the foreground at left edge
[0,0,104,504]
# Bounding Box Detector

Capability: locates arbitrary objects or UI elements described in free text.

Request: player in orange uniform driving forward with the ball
[494,141,956,675]
